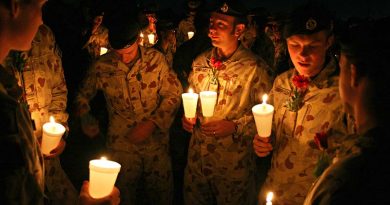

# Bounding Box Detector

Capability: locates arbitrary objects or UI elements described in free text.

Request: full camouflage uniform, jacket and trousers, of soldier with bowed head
[77,47,182,204]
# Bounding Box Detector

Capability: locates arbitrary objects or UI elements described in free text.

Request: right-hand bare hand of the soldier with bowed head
[127,121,156,144]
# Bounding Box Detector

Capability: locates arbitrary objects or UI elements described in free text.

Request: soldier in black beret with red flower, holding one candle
[254,4,354,204]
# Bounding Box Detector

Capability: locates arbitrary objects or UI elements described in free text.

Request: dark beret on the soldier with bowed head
[108,18,141,49]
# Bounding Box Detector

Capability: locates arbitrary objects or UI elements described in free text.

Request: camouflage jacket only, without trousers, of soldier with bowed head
[77,47,182,151]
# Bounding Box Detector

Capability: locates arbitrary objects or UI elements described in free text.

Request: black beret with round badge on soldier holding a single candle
[283,3,333,38]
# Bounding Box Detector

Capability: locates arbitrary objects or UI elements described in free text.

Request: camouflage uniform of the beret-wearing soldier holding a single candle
[259,59,354,204]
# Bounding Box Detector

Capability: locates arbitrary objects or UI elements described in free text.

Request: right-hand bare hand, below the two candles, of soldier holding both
[201,120,236,137]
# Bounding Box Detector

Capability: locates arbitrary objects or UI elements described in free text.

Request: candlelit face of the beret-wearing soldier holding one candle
[287,31,332,77]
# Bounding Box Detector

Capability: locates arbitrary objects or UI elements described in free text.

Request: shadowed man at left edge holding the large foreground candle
[0,0,119,205]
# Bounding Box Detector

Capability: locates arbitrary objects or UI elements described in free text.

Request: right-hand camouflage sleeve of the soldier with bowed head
[150,59,182,130]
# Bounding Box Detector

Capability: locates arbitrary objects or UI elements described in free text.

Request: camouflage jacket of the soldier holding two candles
[189,46,270,171]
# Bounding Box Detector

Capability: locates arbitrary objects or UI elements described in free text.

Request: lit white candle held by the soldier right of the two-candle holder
[252,94,274,137]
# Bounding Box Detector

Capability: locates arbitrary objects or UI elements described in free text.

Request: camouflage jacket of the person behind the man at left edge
[5,25,68,137]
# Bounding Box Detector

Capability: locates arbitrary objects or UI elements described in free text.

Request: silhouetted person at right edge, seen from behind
[304,20,390,204]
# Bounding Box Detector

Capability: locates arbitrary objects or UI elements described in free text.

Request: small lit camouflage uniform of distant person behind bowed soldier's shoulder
[83,25,109,59]
